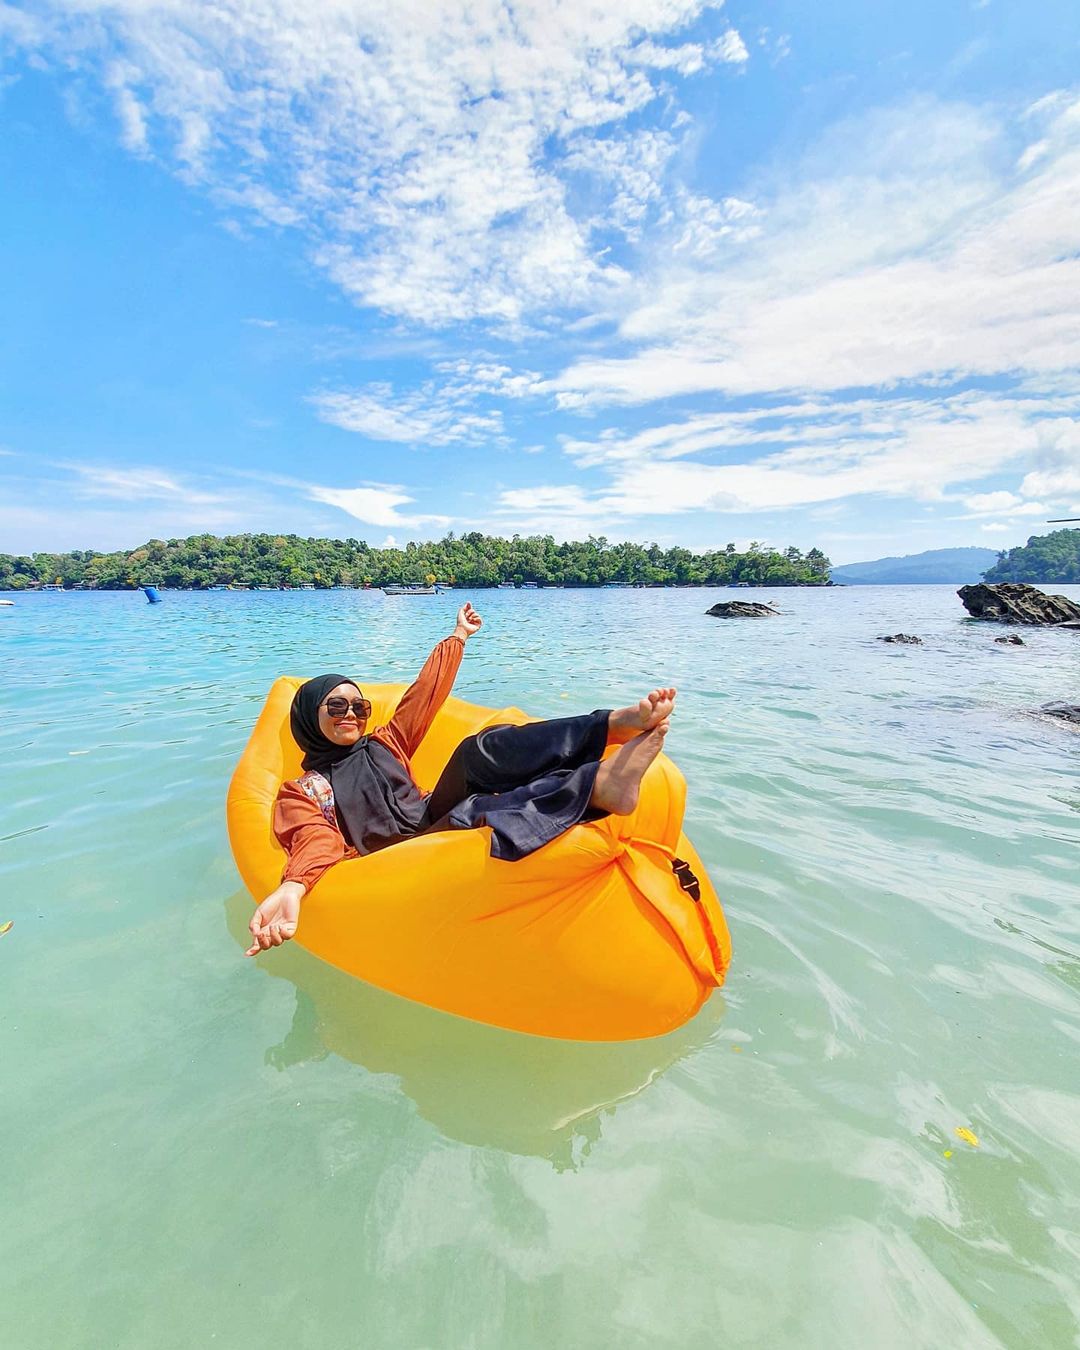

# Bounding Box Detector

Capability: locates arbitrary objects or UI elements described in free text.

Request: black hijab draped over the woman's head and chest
[289,675,427,853]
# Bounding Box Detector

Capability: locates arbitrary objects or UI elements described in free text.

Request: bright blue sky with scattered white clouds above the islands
[0,0,1080,563]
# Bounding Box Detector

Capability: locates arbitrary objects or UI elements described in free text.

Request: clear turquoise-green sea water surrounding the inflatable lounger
[0,587,1080,1350]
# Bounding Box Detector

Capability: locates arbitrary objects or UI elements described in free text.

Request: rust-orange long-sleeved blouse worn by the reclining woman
[274,637,464,891]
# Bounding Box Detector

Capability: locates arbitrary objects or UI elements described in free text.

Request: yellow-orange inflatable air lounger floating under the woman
[228,676,730,1041]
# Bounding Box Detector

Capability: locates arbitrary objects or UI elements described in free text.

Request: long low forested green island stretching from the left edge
[0,532,830,590]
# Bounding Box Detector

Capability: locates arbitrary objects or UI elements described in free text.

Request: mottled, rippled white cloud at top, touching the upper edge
[16,0,747,325]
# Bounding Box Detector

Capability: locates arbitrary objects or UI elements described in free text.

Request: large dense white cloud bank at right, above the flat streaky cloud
[549,100,1080,408]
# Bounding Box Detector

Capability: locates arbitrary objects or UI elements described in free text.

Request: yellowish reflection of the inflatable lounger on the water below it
[225,891,724,1169]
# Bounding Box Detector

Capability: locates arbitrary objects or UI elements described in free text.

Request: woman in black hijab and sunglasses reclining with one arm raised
[244,603,675,956]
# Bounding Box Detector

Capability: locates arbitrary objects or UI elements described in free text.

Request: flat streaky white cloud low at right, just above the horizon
[500,393,1077,518]
